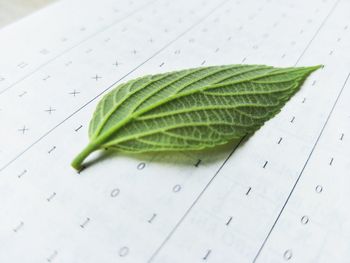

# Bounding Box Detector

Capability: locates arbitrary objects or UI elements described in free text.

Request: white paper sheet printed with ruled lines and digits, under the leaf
[0,0,350,263]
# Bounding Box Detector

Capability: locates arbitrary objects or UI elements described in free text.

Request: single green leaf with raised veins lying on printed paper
[72,65,320,169]
